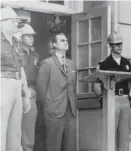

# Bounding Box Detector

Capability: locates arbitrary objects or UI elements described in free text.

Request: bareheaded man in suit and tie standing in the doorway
[37,33,76,151]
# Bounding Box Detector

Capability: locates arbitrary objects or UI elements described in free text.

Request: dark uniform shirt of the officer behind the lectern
[99,55,131,94]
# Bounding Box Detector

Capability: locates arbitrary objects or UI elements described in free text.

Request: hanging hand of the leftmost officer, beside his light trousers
[23,97,31,113]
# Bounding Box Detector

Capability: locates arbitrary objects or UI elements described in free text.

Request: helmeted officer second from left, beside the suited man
[19,24,39,151]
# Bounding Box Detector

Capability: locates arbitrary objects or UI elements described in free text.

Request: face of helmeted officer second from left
[22,34,34,47]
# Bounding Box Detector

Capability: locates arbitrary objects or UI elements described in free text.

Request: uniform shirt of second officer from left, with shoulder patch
[20,45,39,85]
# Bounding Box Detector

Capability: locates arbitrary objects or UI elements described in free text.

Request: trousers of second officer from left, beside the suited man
[21,85,37,151]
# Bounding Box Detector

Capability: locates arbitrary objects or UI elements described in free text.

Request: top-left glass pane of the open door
[78,20,89,44]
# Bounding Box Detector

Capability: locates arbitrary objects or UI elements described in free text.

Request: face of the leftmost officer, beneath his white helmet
[1,19,18,33]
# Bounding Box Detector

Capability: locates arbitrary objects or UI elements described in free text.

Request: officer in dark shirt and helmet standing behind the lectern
[95,31,131,151]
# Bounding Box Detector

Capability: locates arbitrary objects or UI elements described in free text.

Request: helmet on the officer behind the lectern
[108,31,123,44]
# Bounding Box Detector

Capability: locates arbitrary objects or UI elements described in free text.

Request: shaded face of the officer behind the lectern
[111,43,122,54]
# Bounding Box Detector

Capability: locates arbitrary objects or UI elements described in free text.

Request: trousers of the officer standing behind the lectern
[115,95,130,151]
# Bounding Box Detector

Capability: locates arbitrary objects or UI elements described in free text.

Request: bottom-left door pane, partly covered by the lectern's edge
[78,71,89,93]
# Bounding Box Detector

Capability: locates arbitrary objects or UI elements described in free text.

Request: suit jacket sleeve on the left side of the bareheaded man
[36,61,50,102]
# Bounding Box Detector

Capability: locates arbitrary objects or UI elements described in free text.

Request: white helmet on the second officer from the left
[19,24,36,35]
